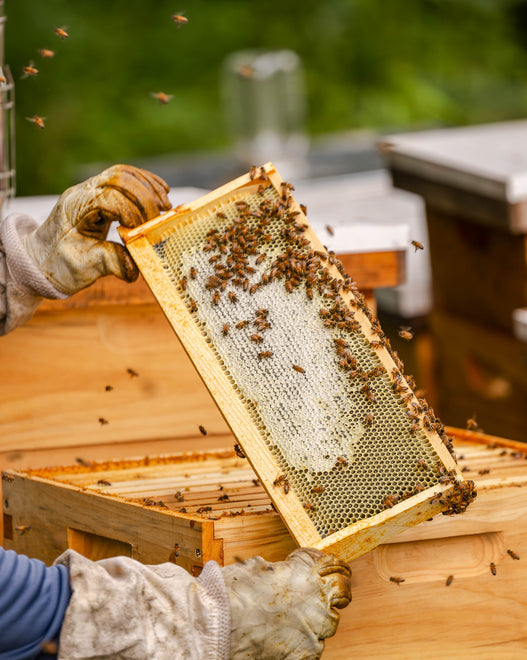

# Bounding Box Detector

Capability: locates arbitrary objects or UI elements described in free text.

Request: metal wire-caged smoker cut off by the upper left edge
[0,0,15,217]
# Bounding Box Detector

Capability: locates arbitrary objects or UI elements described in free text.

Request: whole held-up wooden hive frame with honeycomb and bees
[121,164,474,560]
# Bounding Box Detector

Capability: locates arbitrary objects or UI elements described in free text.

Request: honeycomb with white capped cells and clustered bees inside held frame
[145,177,462,538]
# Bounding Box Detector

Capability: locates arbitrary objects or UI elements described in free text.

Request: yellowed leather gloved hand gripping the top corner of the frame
[25,165,171,295]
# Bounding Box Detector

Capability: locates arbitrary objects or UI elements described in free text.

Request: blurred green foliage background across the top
[6,0,527,195]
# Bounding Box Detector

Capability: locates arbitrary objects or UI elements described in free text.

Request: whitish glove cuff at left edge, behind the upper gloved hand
[0,213,67,335]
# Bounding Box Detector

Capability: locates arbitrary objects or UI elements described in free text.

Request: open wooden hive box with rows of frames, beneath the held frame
[2,429,527,660]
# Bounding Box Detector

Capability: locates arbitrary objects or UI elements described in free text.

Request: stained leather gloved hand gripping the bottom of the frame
[223,548,351,660]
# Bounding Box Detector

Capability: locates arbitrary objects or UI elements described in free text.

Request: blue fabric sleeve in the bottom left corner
[0,547,71,660]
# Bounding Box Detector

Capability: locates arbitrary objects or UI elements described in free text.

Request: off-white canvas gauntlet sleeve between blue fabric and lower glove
[55,550,231,660]
